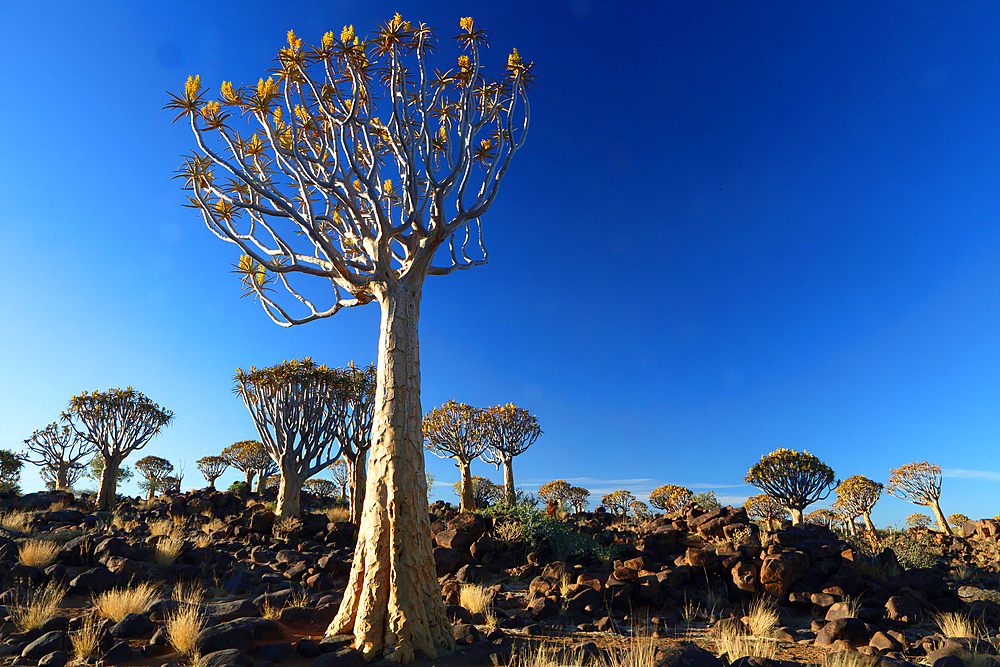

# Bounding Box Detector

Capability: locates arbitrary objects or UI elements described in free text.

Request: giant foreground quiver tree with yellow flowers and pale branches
[167,14,532,663]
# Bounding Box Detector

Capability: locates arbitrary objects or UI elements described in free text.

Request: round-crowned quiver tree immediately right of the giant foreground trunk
[423,400,486,512]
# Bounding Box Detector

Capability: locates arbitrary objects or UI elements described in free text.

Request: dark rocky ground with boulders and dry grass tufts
[0,490,1000,667]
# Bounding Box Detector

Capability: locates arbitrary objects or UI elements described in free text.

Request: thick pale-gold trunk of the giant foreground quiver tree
[326,284,455,664]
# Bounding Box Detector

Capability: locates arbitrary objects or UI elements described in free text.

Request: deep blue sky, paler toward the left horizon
[0,0,1000,525]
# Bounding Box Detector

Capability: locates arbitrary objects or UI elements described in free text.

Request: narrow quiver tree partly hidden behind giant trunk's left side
[337,364,376,523]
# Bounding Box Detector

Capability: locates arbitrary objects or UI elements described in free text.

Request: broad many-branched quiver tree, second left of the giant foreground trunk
[233,357,347,519]
